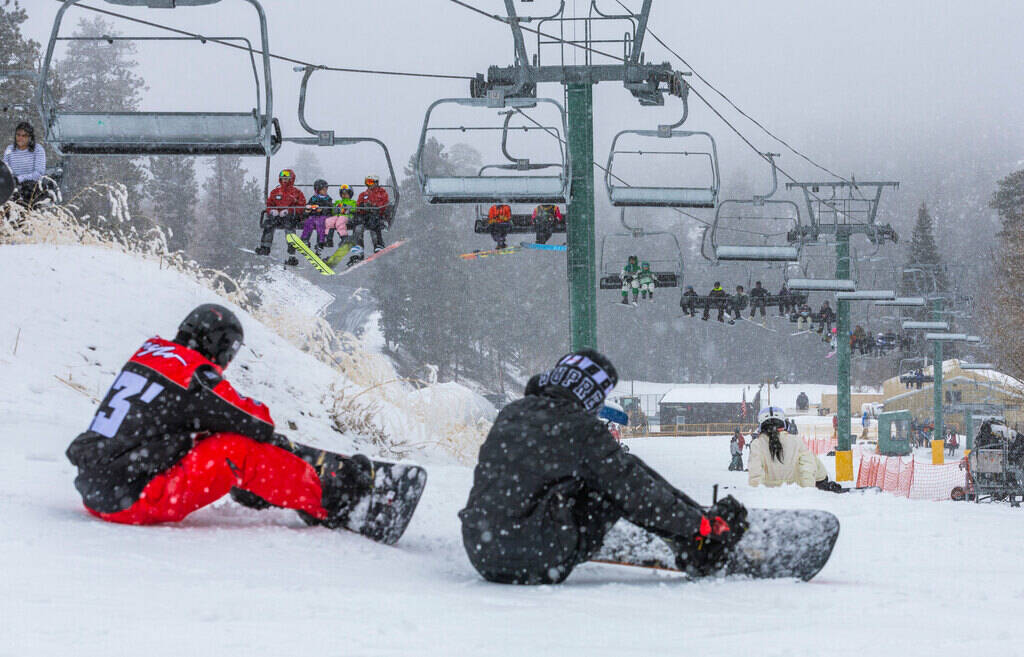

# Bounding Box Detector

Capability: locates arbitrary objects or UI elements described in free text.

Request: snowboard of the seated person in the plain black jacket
[591,509,839,581]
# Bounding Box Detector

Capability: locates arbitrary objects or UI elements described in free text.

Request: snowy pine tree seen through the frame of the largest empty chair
[56,16,145,217]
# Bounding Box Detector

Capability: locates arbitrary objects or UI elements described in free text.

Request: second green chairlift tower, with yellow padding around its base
[785,179,899,481]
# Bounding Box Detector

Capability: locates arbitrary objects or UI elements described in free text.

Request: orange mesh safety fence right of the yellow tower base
[857,454,967,499]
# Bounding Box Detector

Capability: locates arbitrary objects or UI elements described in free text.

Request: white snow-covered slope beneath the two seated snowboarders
[0,246,1024,657]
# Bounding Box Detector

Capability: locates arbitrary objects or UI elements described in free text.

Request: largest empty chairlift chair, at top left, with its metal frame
[37,0,281,157]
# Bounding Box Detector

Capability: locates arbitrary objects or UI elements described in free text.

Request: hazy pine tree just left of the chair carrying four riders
[188,156,263,268]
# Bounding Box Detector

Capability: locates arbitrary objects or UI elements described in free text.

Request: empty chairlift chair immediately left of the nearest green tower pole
[416,94,572,204]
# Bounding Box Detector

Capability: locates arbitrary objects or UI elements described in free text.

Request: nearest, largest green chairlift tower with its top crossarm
[470,0,688,350]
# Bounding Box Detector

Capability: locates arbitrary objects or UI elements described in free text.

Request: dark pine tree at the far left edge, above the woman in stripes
[0,0,40,157]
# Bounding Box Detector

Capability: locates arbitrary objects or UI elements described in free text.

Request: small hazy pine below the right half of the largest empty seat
[145,156,199,251]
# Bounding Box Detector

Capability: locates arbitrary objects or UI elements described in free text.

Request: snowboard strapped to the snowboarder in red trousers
[282,441,427,545]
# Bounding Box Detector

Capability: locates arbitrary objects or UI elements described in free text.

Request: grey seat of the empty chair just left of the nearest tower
[423,176,567,203]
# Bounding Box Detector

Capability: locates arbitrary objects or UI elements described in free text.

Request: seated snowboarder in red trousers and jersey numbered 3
[67,304,373,527]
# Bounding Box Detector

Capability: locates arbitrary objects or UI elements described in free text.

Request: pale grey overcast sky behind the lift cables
[23,0,1024,212]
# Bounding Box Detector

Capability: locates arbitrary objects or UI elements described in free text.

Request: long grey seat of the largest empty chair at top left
[47,112,273,156]
